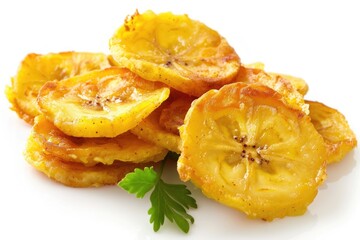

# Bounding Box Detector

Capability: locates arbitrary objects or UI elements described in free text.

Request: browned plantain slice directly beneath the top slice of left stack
[32,115,168,166]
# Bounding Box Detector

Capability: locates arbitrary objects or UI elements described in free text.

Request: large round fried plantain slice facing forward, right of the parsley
[178,83,326,220]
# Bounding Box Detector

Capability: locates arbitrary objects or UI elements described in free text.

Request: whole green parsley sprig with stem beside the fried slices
[118,153,197,233]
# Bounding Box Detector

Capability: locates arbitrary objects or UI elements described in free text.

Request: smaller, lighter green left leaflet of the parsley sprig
[118,167,157,198]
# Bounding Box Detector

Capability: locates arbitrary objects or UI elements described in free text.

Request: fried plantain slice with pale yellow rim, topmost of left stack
[38,67,170,137]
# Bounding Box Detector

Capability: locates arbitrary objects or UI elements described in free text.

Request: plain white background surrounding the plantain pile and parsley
[0,0,360,240]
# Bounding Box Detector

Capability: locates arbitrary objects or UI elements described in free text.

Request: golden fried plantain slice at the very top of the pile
[110,11,240,96]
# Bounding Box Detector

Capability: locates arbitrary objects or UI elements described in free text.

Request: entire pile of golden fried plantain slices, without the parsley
[6,8,357,221]
